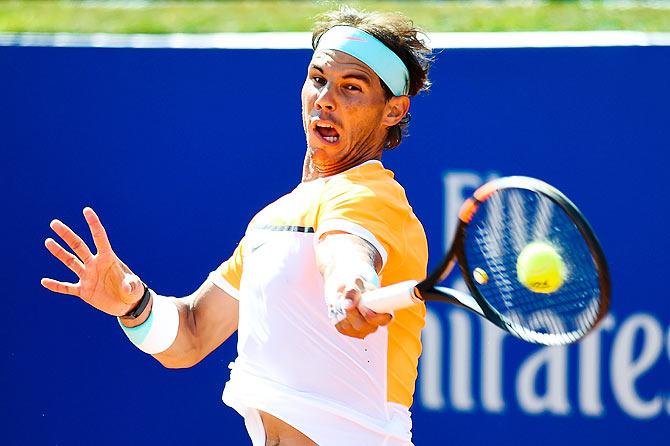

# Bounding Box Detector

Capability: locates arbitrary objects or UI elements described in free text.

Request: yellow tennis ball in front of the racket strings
[516,242,566,294]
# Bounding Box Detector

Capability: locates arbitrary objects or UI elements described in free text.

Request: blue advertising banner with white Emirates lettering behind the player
[0,40,670,446]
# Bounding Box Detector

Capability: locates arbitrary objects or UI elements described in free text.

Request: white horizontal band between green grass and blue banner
[0,31,670,49]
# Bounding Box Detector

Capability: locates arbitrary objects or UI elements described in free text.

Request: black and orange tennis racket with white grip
[362,177,610,345]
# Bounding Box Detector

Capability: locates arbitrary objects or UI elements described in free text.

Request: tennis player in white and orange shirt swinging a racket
[42,8,430,446]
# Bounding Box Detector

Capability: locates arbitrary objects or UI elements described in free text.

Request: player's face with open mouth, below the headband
[302,50,389,172]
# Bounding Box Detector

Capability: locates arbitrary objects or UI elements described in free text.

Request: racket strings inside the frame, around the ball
[464,189,600,343]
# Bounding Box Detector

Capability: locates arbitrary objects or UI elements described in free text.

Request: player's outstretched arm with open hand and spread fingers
[41,208,239,368]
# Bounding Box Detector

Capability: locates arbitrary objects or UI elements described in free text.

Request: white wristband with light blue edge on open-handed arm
[119,291,179,355]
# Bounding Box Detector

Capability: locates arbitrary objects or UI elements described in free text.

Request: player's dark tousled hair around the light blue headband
[312,6,433,149]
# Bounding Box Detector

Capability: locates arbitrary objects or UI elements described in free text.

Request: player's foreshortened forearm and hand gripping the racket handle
[316,232,392,339]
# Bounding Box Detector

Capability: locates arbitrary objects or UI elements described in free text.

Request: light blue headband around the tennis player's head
[314,25,409,96]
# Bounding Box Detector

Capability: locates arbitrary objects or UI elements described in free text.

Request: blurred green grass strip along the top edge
[0,0,670,33]
